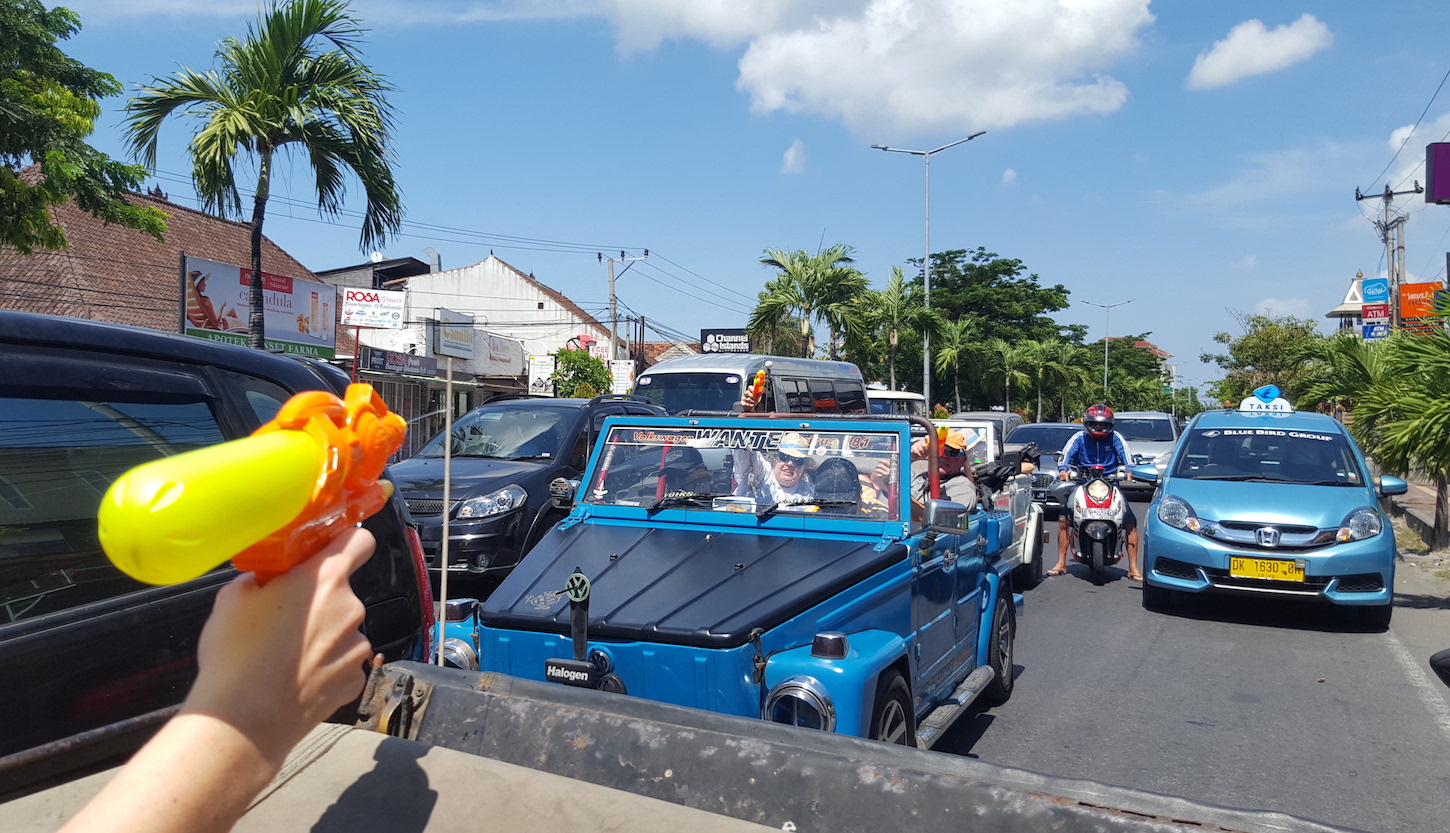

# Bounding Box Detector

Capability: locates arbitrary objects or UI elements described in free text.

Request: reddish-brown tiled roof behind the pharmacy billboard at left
[0,165,314,335]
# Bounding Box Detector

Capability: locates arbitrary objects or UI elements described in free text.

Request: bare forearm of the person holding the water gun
[62,713,281,833]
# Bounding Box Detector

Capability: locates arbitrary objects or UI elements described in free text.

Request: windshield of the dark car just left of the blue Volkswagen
[415,402,574,460]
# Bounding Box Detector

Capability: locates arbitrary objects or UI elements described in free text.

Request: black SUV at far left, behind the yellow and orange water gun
[0,311,434,795]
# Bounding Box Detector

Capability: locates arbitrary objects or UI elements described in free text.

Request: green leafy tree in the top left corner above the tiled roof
[0,0,167,254]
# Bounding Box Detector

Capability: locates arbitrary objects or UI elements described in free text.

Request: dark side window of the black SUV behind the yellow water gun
[0,396,225,624]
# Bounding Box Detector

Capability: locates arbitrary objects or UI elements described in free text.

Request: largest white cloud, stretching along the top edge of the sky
[68,0,1154,141]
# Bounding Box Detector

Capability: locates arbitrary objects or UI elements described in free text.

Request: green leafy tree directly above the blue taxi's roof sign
[1199,311,1324,402]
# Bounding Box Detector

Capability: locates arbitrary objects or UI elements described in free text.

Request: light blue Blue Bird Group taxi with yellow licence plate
[1132,386,1408,627]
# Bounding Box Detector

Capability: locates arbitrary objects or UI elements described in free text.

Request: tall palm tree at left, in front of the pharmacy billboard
[126,0,403,348]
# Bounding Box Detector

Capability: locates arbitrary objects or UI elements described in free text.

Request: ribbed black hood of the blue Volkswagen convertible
[483,521,906,647]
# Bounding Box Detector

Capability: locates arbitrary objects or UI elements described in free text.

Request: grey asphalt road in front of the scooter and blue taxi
[937,504,1450,833]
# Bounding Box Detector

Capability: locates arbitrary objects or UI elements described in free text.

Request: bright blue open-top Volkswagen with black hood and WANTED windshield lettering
[464,415,1021,746]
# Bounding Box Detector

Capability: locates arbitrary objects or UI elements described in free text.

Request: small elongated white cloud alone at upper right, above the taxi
[1188,15,1334,90]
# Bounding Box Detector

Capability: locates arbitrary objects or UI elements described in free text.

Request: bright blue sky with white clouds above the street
[64,0,1450,394]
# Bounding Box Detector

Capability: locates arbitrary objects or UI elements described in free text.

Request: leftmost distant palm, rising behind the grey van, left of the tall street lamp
[745,244,867,358]
